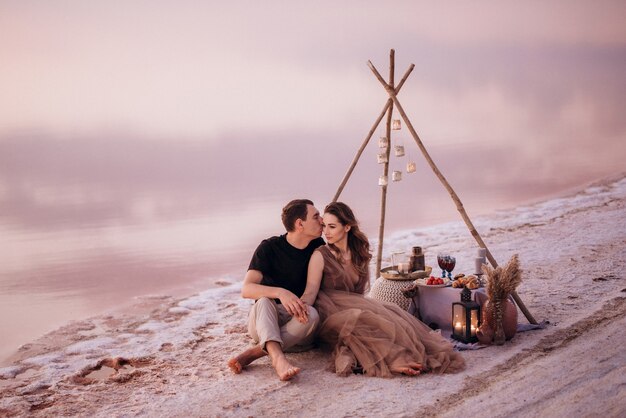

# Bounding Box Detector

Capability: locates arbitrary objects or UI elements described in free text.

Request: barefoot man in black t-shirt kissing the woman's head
[228,199,324,381]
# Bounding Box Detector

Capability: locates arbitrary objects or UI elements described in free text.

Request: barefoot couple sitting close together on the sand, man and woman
[228,199,465,380]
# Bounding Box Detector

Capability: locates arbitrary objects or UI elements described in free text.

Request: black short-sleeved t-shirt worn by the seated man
[248,234,325,302]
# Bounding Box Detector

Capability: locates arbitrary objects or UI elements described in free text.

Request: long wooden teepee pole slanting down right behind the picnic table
[368,61,537,324]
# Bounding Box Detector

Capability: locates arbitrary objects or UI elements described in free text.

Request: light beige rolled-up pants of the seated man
[248,298,319,352]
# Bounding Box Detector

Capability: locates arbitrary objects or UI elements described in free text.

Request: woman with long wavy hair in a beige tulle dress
[302,202,465,377]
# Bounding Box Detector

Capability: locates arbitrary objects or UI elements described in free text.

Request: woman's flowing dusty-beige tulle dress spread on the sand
[315,246,465,377]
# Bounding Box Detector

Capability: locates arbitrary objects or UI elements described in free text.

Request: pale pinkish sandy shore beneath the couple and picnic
[0,175,626,417]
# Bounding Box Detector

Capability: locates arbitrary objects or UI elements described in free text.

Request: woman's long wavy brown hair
[324,202,372,276]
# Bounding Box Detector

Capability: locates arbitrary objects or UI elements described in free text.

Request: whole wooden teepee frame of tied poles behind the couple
[333,49,537,324]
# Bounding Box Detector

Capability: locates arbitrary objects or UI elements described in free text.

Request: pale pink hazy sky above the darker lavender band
[0,0,626,140]
